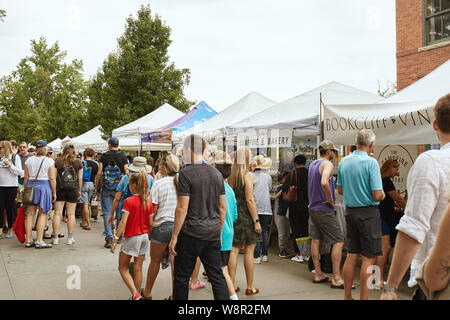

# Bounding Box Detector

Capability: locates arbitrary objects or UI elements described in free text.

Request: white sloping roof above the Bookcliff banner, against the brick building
[381,59,450,103]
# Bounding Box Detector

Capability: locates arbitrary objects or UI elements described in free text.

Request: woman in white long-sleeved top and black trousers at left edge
[0,141,23,239]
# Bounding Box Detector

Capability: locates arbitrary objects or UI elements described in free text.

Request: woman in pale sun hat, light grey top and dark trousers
[253,155,272,263]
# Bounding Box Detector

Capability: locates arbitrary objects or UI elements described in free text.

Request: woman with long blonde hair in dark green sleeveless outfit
[228,147,262,295]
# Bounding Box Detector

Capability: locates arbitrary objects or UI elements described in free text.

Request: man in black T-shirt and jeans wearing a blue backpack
[96,137,128,248]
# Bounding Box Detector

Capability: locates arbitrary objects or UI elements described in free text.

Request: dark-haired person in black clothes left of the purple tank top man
[282,154,309,262]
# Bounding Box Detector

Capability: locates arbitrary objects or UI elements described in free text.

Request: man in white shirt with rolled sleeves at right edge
[381,94,450,300]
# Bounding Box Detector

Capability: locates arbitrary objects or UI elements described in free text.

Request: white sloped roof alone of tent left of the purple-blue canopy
[112,103,183,137]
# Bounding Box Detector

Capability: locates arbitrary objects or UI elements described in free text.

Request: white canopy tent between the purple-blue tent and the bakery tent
[179,91,277,140]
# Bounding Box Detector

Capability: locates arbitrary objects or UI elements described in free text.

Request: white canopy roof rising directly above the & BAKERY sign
[231,81,382,134]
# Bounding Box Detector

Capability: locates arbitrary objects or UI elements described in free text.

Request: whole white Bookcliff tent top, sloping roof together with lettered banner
[324,60,450,145]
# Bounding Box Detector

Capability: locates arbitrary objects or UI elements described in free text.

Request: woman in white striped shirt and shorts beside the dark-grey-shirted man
[141,153,180,299]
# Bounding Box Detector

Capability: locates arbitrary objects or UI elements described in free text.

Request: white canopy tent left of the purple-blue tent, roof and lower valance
[112,103,183,151]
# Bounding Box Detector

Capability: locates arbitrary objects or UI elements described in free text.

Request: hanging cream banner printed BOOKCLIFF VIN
[323,102,438,145]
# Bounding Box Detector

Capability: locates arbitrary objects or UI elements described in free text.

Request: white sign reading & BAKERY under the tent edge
[237,129,292,148]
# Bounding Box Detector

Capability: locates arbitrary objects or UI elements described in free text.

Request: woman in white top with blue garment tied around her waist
[23,140,56,249]
